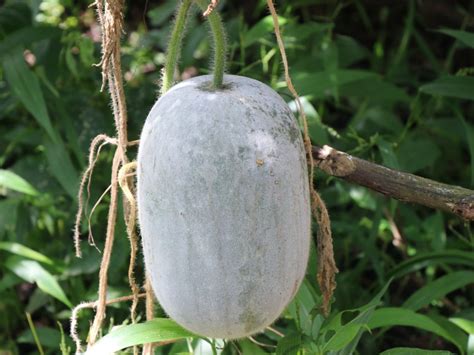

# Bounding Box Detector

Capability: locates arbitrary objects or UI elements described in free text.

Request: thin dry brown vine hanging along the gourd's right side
[267,0,338,315]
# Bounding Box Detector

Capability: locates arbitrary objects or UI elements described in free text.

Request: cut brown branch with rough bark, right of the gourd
[313,145,474,221]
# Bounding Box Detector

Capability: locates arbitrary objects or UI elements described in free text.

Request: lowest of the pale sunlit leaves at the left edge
[5,256,72,308]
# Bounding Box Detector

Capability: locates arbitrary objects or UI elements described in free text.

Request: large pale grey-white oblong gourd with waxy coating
[138,75,311,339]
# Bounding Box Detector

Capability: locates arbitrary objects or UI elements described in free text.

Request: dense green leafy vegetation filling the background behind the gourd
[0,0,474,354]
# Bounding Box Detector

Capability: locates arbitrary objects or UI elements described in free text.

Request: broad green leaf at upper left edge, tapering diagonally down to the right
[3,50,57,142]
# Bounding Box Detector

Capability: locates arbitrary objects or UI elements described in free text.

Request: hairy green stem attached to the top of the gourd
[196,0,227,89]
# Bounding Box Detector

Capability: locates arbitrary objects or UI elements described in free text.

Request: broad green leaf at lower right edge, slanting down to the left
[403,271,474,311]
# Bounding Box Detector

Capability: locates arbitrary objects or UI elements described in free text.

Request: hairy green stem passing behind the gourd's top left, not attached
[161,0,192,95]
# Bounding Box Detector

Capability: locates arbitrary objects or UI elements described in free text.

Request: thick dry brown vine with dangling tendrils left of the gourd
[75,0,138,345]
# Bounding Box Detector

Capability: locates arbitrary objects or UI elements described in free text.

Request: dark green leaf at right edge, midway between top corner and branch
[420,76,474,100]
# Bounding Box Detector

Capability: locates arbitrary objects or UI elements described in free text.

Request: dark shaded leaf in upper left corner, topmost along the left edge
[0,26,61,59]
